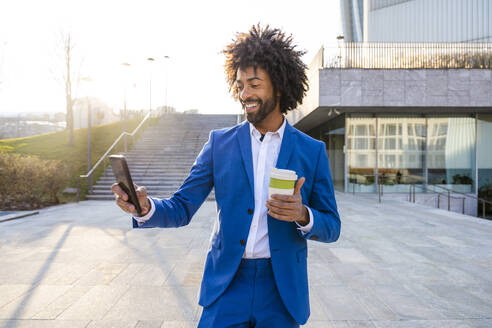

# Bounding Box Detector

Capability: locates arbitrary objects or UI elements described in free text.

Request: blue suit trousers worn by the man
[198,259,299,328]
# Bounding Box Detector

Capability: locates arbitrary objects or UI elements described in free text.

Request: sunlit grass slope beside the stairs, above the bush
[0,118,158,203]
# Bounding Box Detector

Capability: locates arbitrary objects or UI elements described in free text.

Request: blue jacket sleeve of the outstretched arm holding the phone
[132,131,214,228]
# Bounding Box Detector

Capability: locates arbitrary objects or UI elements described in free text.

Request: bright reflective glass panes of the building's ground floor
[346,115,476,193]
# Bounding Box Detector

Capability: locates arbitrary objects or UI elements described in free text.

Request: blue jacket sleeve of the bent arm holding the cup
[299,144,341,243]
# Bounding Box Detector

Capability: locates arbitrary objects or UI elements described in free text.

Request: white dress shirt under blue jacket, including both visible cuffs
[134,118,314,258]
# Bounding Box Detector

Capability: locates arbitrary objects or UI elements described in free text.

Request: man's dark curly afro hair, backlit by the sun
[222,24,308,113]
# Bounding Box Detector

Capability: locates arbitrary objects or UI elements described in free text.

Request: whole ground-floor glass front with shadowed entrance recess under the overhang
[309,114,492,218]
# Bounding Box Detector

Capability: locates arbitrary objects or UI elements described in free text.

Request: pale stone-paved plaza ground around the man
[0,194,492,328]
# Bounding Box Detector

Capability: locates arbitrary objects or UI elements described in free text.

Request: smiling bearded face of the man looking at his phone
[236,66,282,126]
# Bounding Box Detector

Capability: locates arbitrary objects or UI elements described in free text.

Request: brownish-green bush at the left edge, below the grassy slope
[0,153,70,210]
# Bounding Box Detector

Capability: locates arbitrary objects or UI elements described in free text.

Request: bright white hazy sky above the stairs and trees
[0,0,341,114]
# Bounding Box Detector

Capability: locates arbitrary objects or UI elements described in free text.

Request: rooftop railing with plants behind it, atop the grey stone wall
[323,42,492,69]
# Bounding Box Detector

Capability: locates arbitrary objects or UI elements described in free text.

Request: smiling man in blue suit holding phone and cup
[112,25,340,328]
